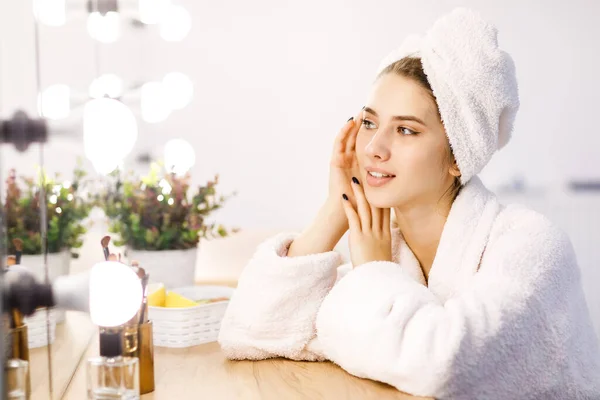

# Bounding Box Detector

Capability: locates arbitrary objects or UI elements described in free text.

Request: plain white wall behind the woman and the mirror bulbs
[0,0,600,319]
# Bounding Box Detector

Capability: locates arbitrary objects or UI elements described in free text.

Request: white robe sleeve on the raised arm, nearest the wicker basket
[219,233,349,361]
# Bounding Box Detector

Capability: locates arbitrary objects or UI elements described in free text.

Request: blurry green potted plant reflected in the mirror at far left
[3,163,93,321]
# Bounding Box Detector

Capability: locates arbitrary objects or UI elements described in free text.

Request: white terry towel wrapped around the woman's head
[378,8,519,185]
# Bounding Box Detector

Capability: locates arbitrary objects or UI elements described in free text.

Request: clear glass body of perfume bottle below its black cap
[87,356,140,400]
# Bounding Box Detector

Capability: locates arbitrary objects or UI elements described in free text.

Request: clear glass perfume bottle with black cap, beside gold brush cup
[87,329,140,400]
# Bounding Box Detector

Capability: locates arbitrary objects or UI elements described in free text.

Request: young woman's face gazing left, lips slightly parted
[356,73,458,209]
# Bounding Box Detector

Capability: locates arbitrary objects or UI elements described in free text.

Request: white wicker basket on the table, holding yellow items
[148,286,234,347]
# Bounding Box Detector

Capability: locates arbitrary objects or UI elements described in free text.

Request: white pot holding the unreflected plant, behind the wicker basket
[127,247,198,289]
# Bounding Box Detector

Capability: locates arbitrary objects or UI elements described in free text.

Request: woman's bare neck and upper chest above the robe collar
[394,203,452,281]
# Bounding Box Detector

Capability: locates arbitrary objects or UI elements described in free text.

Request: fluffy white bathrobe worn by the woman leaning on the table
[219,177,600,400]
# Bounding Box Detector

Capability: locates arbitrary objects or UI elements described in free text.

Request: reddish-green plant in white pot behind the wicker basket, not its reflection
[98,163,235,288]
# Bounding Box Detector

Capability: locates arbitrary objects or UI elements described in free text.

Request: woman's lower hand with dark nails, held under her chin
[341,177,392,267]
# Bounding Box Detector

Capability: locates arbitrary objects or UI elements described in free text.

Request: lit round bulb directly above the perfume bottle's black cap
[90,261,143,327]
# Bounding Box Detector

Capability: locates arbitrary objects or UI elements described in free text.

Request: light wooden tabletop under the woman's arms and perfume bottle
[63,339,432,400]
